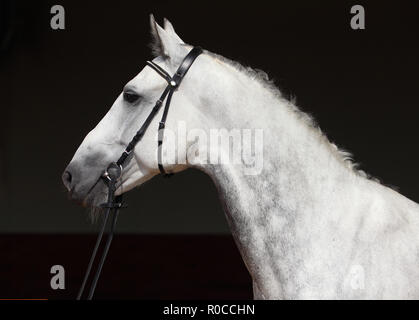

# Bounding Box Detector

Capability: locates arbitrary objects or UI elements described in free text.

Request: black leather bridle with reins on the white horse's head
[77,47,202,300]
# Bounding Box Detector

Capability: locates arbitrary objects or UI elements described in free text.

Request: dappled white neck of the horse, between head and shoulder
[192,58,358,296]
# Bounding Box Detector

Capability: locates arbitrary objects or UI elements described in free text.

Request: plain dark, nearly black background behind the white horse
[0,0,419,298]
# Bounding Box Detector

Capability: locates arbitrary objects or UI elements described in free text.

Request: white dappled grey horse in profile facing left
[63,17,419,299]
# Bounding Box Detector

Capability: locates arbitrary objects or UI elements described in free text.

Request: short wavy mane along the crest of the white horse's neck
[205,50,386,185]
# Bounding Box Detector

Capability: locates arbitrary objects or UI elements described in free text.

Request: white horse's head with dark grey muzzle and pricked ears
[62,15,208,207]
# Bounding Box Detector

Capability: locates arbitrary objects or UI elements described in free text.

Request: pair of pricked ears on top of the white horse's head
[150,14,183,59]
